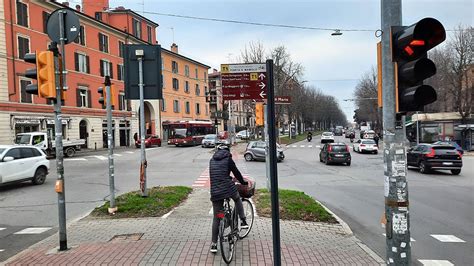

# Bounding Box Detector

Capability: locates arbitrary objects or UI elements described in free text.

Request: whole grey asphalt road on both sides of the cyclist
[0,136,474,265]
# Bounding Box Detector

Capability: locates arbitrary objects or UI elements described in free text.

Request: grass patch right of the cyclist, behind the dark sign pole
[253,189,338,224]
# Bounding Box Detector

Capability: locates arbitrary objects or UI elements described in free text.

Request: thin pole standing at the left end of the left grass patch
[104,76,117,214]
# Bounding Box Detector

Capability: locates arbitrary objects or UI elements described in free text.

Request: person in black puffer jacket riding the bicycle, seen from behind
[209,145,248,253]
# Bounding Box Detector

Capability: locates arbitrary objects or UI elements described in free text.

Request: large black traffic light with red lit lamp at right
[391,18,446,112]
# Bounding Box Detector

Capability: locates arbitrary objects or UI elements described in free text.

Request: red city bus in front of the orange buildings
[163,121,214,147]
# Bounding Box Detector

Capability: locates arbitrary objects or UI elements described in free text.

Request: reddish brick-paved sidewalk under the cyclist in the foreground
[6,189,386,265]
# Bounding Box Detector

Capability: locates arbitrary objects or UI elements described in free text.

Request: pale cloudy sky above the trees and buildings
[70,0,474,120]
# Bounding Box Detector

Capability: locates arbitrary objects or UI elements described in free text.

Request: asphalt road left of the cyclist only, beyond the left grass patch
[0,143,211,264]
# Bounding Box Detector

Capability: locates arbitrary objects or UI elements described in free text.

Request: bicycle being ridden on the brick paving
[217,195,254,264]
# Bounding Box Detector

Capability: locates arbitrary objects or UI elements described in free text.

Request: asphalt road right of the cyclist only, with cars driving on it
[246,137,474,265]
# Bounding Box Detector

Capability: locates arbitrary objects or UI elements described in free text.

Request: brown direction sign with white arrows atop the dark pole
[221,64,267,100]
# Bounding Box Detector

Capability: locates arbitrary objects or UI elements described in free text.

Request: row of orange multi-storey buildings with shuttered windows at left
[0,0,208,148]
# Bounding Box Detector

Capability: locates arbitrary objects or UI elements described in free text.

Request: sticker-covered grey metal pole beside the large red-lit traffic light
[381,0,411,265]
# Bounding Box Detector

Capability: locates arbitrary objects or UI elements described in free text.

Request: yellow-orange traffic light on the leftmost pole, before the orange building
[24,51,56,99]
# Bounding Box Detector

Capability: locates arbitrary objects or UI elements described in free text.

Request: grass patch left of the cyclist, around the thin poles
[89,186,192,219]
